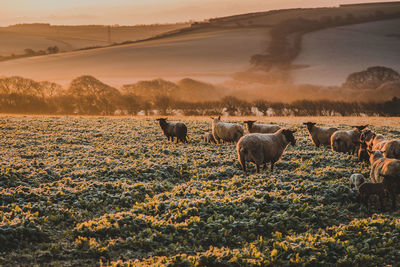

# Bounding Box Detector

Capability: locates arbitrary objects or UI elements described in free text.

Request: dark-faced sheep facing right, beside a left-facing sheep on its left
[331,125,367,154]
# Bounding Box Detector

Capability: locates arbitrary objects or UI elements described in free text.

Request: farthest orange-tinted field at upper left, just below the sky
[0,23,189,56]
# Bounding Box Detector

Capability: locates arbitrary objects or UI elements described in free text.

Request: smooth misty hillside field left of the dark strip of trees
[0,28,268,86]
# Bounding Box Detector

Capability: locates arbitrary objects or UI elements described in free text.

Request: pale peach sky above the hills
[0,0,394,26]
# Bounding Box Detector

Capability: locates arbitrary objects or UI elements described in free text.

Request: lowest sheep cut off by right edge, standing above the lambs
[368,150,400,209]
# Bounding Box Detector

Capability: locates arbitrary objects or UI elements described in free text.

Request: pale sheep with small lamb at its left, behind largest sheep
[211,116,244,143]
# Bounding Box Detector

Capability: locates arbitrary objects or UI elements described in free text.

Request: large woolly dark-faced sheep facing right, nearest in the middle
[236,128,296,173]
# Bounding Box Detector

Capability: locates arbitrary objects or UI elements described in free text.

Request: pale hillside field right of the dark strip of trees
[293,19,400,85]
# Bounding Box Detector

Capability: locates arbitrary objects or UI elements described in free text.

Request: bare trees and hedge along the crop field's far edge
[0,76,400,116]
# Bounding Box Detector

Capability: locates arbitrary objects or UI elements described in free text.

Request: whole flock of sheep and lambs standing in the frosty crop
[157,117,400,209]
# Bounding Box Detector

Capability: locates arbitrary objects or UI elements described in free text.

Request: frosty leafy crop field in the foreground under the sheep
[0,116,400,266]
